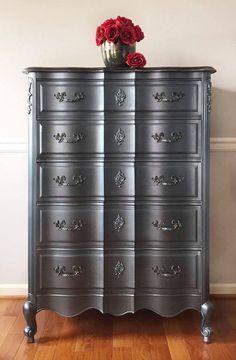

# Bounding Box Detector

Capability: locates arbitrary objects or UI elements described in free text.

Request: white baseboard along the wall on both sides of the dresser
[0,283,236,297]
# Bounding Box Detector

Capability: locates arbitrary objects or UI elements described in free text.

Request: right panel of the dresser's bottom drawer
[135,250,201,293]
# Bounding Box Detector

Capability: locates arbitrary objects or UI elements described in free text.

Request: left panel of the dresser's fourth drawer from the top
[37,205,104,247]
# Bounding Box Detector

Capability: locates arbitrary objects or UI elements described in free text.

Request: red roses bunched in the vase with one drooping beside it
[96,16,146,67]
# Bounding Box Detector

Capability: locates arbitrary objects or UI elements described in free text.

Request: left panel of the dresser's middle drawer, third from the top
[38,161,104,200]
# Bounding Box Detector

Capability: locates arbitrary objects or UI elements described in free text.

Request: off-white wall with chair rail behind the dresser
[0,0,236,292]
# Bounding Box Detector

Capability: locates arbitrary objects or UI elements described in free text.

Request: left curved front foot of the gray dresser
[23,301,37,343]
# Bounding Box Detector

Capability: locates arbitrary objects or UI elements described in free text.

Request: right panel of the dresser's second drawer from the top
[136,121,201,157]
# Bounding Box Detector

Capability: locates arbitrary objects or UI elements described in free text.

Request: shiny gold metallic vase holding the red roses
[101,41,136,68]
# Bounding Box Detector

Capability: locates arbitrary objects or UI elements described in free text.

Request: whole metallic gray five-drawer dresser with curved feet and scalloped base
[23,67,215,342]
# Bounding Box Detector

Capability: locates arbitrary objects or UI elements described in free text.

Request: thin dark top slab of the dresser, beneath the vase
[23,66,216,74]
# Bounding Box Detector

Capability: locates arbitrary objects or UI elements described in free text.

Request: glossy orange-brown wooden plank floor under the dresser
[0,298,236,360]
